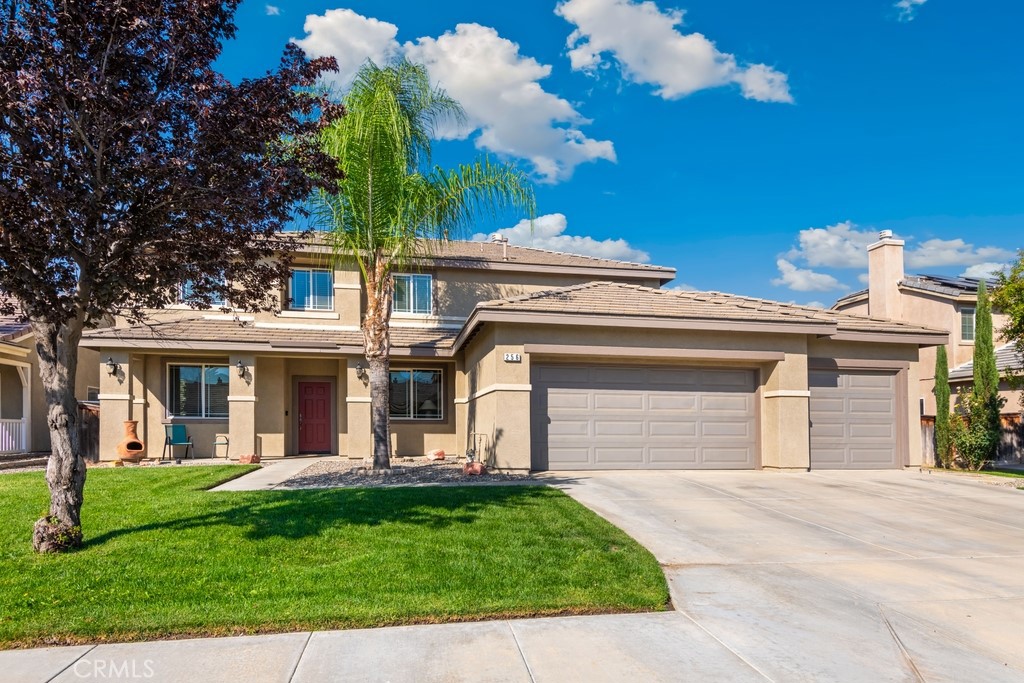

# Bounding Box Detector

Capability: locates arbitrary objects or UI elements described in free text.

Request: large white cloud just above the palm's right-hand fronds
[404,24,615,181]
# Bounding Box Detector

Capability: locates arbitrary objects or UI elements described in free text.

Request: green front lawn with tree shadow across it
[0,466,669,647]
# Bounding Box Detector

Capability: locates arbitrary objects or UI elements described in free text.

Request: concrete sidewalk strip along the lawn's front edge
[0,612,765,683]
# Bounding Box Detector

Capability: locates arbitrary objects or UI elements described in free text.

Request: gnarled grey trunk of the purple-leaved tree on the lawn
[32,316,85,553]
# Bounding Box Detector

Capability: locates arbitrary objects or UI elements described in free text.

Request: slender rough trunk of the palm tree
[362,253,393,469]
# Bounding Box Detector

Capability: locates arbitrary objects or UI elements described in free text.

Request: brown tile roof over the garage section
[476,282,946,335]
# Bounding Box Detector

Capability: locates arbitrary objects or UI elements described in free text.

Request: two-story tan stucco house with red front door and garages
[83,236,947,470]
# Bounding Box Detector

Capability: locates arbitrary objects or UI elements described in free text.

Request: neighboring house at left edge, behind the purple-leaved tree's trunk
[0,296,99,454]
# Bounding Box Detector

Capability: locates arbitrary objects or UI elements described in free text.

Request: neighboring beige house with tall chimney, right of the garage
[833,230,1022,417]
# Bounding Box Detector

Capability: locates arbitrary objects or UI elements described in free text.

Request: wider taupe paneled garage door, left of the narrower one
[531,365,756,470]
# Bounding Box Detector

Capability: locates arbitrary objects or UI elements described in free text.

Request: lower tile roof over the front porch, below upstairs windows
[83,317,457,350]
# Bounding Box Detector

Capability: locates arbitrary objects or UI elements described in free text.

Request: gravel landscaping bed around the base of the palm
[278,458,534,488]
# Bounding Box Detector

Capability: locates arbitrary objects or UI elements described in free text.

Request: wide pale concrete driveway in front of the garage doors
[548,471,1024,682]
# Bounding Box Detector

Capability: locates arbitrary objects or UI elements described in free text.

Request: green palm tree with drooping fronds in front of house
[318,60,535,469]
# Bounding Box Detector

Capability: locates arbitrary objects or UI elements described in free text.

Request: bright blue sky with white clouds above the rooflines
[219,0,1024,305]
